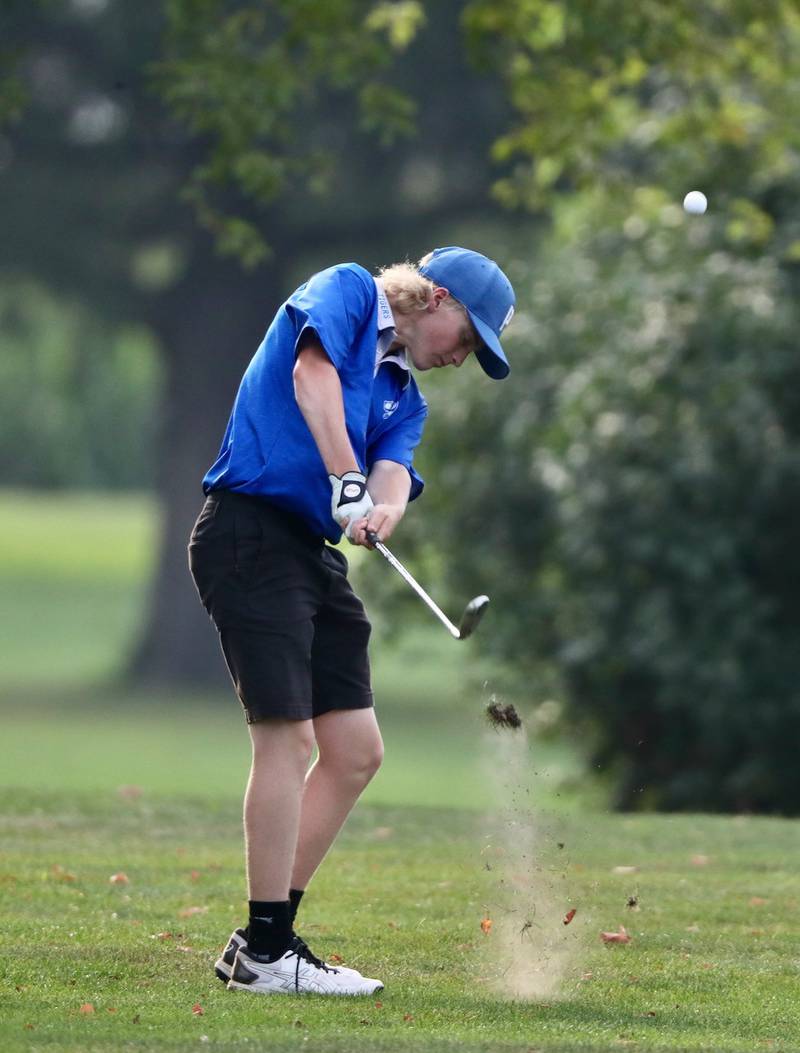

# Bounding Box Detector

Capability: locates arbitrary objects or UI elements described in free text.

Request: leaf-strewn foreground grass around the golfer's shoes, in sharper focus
[0,791,800,1053]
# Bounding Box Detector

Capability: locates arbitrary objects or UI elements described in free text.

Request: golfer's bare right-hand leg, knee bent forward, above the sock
[292,709,383,889]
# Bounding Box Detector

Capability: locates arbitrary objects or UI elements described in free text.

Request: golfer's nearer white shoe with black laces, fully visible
[227,939,383,995]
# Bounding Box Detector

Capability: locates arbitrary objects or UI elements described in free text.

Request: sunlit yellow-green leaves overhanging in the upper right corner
[464,0,800,232]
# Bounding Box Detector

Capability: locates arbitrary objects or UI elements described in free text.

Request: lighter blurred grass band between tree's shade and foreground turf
[0,691,597,809]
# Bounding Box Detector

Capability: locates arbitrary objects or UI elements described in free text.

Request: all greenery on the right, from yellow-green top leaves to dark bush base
[412,2,800,813]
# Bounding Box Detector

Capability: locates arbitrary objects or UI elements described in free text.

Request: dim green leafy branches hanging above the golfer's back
[153,0,424,267]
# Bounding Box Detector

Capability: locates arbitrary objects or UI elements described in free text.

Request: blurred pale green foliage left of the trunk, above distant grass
[0,281,161,489]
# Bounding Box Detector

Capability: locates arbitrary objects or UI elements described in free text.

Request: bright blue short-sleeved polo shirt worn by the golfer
[203,263,427,543]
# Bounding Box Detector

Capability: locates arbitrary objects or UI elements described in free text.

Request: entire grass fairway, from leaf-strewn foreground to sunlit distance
[0,495,800,1053]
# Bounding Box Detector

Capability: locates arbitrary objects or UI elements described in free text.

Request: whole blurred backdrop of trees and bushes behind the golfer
[0,0,800,812]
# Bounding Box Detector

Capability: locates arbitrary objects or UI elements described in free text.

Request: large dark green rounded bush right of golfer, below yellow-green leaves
[418,202,800,813]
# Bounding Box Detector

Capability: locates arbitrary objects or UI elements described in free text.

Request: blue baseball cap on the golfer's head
[419,245,517,380]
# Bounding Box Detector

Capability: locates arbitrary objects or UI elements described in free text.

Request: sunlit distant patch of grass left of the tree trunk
[0,491,158,692]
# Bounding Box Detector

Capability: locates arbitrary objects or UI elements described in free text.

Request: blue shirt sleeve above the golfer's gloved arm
[286,266,375,372]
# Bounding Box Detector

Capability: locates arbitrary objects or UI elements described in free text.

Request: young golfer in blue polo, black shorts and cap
[189,246,515,995]
